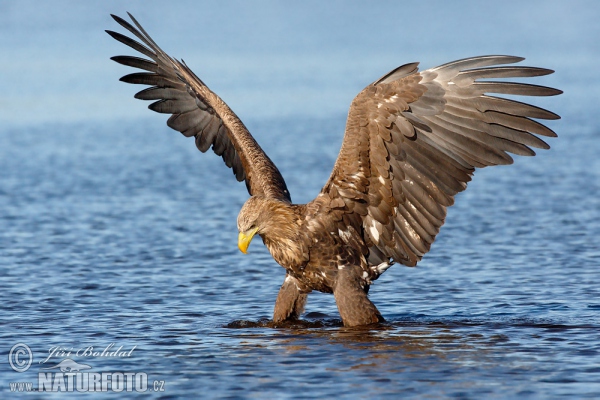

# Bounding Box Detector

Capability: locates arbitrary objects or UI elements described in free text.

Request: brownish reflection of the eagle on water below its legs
[225,320,506,376]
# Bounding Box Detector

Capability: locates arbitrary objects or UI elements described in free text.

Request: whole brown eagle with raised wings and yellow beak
[107,15,561,326]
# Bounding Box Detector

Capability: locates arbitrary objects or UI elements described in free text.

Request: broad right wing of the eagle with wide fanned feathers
[319,56,562,266]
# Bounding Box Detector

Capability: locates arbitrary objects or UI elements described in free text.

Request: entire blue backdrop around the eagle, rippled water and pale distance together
[0,2,600,399]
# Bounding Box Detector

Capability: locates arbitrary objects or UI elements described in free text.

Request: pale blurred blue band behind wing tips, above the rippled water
[0,0,600,126]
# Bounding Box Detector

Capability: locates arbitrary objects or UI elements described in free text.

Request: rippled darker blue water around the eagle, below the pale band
[0,116,600,398]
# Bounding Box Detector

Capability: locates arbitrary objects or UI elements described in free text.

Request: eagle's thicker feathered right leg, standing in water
[333,266,384,326]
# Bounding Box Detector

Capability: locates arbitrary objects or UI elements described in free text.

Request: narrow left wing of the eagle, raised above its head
[106,14,291,201]
